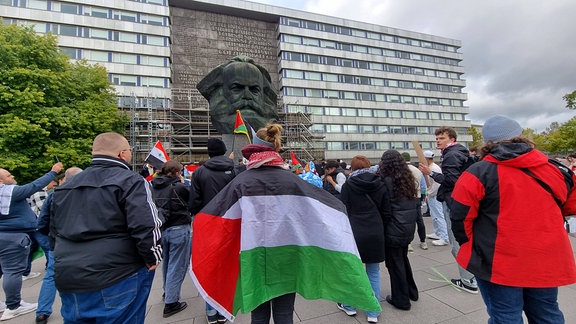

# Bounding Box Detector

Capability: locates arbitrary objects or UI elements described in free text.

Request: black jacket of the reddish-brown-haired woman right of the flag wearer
[340,172,389,263]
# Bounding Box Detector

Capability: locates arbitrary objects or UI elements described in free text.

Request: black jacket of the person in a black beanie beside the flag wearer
[189,155,236,214]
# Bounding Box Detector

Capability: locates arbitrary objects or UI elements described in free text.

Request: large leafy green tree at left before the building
[0,25,128,183]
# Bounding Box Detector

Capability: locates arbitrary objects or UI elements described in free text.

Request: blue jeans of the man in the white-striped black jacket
[60,267,154,324]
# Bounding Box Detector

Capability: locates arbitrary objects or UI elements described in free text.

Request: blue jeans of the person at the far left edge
[0,232,31,309]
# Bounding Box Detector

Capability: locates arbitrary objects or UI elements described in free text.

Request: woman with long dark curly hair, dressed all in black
[378,150,420,310]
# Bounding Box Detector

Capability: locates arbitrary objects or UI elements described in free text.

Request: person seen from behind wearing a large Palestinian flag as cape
[191,124,381,324]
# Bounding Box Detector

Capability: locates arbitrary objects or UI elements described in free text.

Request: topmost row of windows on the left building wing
[0,0,168,26]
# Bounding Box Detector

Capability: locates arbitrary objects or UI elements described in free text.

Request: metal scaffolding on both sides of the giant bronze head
[118,88,324,169]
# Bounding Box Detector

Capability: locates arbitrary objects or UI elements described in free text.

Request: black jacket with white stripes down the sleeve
[50,156,162,292]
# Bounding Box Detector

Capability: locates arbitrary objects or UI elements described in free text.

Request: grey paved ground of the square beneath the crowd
[0,217,576,324]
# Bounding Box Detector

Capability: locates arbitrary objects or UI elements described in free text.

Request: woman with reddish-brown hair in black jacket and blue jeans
[337,155,389,323]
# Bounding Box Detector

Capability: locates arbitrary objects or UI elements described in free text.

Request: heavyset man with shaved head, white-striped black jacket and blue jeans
[50,133,162,323]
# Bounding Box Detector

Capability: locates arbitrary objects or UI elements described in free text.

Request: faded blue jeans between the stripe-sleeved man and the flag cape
[162,224,192,304]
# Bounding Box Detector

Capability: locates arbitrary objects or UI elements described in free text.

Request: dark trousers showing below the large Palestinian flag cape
[251,293,296,324]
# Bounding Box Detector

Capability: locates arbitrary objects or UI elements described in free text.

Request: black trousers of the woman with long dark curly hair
[385,244,418,309]
